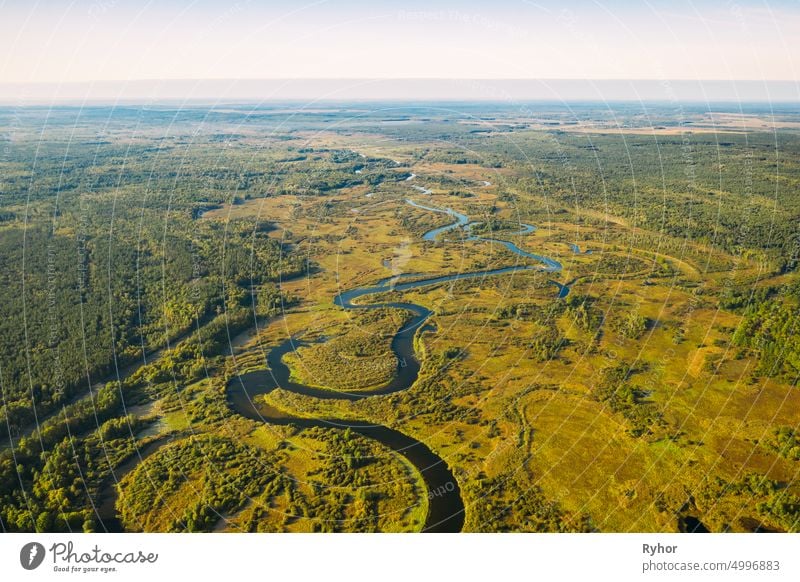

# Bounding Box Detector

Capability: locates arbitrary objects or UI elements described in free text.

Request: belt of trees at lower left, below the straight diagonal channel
[0,296,290,531]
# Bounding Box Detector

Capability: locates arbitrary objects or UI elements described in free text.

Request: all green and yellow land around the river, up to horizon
[0,103,800,532]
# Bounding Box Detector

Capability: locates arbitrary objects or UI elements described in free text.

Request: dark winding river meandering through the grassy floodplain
[227,174,569,532]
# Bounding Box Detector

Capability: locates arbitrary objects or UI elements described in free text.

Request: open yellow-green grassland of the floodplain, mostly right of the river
[212,154,800,531]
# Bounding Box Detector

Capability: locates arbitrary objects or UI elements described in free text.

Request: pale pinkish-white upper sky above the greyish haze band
[0,0,800,83]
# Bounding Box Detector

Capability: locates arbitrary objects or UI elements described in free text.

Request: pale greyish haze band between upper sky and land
[0,77,800,104]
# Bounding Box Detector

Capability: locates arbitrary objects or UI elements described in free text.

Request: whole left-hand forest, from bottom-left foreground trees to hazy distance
[0,112,308,531]
